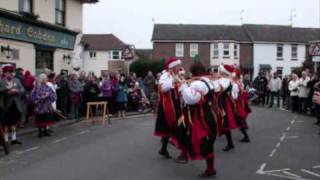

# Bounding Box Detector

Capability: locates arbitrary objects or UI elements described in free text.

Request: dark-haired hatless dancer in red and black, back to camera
[178,63,217,178]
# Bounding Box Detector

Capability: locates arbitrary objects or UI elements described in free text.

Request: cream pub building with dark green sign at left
[0,0,98,73]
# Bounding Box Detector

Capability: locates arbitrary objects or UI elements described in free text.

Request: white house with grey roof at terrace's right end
[244,25,320,77]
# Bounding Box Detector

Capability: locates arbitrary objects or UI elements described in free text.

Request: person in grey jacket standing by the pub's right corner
[68,74,83,119]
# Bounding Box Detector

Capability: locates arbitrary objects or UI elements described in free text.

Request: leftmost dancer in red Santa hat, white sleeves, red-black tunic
[155,58,182,159]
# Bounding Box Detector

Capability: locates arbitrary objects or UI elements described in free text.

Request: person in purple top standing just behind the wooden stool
[100,74,115,113]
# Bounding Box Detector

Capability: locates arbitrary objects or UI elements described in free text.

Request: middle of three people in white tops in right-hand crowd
[289,73,299,112]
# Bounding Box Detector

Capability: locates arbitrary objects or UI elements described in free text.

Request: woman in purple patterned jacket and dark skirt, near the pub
[31,74,57,138]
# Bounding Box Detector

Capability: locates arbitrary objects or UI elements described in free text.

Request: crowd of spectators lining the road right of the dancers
[251,69,320,134]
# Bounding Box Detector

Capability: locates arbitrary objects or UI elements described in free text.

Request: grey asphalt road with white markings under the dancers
[0,107,320,180]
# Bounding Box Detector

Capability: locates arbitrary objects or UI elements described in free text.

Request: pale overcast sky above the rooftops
[83,0,320,49]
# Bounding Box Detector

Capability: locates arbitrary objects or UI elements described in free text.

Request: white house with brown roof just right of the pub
[81,34,127,76]
